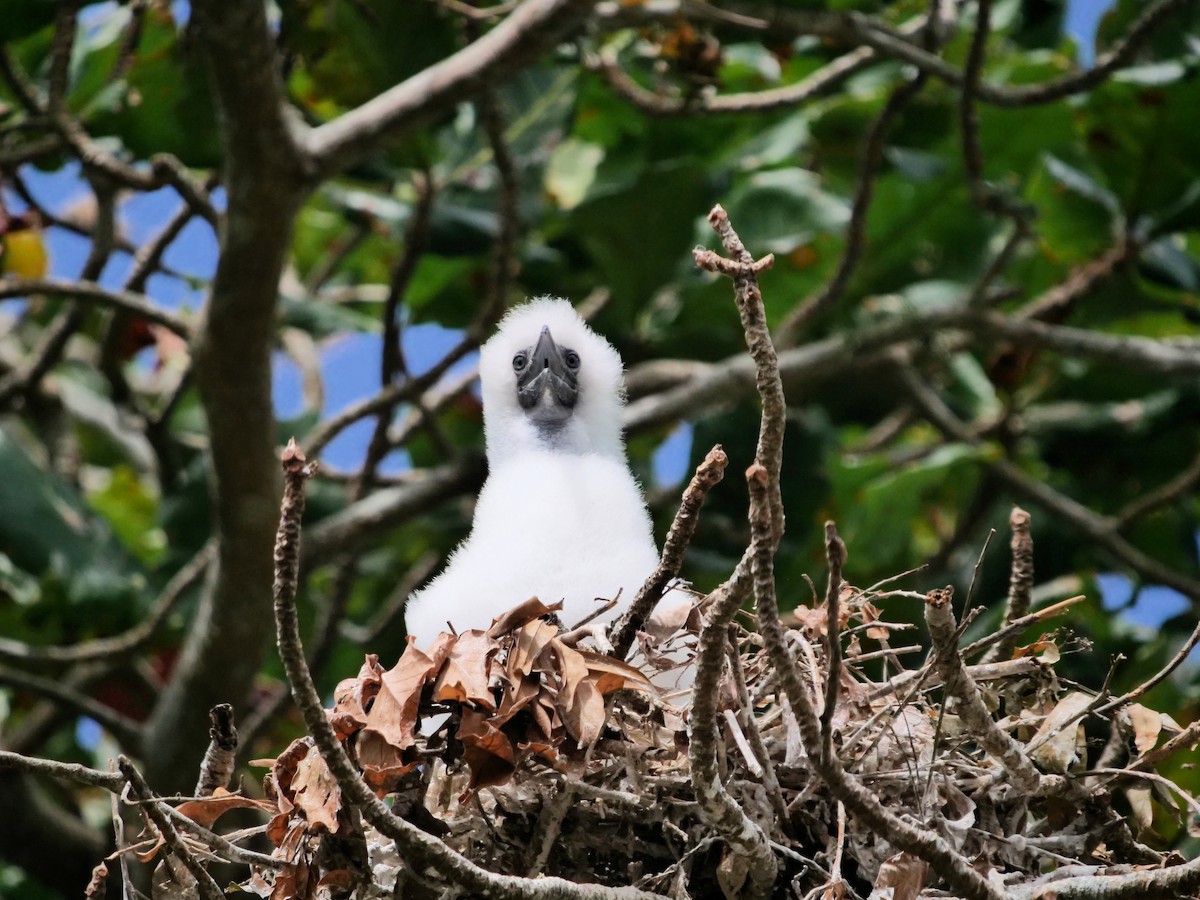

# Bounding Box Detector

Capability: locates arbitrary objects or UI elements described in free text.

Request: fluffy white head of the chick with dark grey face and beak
[479,298,625,466]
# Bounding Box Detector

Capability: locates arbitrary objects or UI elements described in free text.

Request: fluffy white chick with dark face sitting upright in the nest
[406,298,659,647]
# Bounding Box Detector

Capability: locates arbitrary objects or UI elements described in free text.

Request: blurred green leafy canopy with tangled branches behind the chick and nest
[0,0,1200,896]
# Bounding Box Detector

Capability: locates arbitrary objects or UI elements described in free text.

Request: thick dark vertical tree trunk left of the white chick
[146,0,308,791]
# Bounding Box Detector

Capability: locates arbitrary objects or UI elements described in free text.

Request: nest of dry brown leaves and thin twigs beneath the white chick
[246,571,1188,898]
